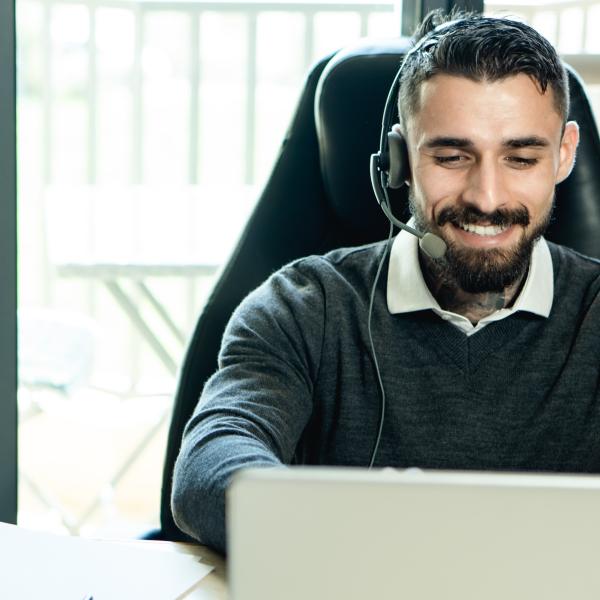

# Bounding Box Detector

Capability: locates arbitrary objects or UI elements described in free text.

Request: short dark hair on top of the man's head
[398,10,569,129]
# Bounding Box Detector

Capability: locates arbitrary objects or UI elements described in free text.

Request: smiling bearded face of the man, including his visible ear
[406,74,578,292]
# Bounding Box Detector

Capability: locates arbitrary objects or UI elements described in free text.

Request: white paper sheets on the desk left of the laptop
[0,523,212,600]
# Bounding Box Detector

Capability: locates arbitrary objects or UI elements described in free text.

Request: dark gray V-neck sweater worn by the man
[172,239,600,551]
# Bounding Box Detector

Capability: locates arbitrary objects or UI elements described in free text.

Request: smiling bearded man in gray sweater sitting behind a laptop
[172,15,600,550]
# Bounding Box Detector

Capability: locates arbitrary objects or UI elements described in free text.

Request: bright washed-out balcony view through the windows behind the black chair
[16,0,600,537]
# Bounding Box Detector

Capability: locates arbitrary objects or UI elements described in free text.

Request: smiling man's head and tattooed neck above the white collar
[396,24,579,325]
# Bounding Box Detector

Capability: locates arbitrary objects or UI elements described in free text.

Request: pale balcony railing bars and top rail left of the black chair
[18,0,395,184]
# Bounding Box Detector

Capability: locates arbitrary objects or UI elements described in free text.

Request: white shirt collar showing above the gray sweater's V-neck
[387,225,554,335]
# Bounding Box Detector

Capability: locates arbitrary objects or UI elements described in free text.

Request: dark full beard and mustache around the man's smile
[409,190,554,294]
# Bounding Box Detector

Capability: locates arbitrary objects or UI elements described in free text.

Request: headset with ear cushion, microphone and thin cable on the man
[367,19,461,469]
